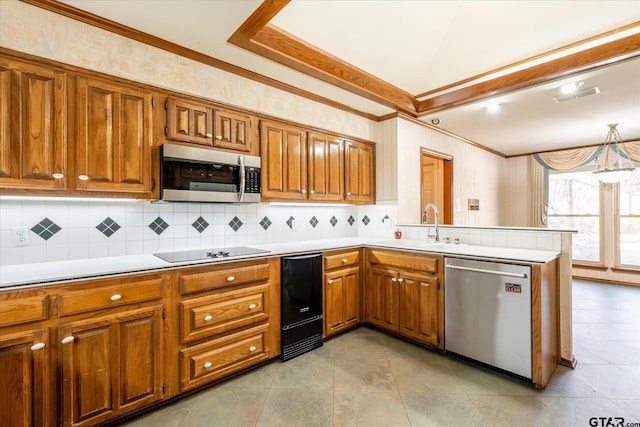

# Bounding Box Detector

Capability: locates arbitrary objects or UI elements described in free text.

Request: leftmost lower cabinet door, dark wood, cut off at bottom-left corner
[0,329,54,427]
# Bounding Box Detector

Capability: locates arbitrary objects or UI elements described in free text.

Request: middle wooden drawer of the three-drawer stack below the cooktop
[180,284,269,343]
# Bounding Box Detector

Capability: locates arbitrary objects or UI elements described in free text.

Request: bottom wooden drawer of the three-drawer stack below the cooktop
[180,324,270,390]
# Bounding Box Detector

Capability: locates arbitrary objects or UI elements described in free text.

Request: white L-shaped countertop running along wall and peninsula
[0,238,560,288]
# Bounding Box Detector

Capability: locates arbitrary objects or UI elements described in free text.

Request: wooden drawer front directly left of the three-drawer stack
[58,278,162,316]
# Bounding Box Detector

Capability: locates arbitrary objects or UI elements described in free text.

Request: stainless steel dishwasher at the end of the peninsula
[444,258,532,379]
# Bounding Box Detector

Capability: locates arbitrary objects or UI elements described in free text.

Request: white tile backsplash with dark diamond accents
[0,200,396,265]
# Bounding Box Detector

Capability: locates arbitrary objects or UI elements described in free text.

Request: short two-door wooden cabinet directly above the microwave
[165,96,260,155]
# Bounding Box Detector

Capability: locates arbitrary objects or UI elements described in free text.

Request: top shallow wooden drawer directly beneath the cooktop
[180,264,269,295]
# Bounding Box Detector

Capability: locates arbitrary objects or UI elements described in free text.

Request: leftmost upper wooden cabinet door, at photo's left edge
[0,60,67,190]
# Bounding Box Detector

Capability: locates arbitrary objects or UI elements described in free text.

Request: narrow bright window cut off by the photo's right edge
[616,172,640,267]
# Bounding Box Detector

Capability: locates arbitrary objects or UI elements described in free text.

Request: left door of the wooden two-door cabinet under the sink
[365,266,399,331]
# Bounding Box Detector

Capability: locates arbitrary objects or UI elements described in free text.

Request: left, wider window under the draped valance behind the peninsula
[547,172,603,264]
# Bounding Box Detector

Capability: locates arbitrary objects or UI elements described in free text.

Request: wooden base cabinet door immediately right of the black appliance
[324,267,360,336]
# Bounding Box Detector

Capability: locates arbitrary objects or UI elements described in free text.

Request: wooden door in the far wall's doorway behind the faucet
[420,150,452,224]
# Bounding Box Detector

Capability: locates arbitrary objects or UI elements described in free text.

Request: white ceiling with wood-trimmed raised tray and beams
[38,0,640,156]
